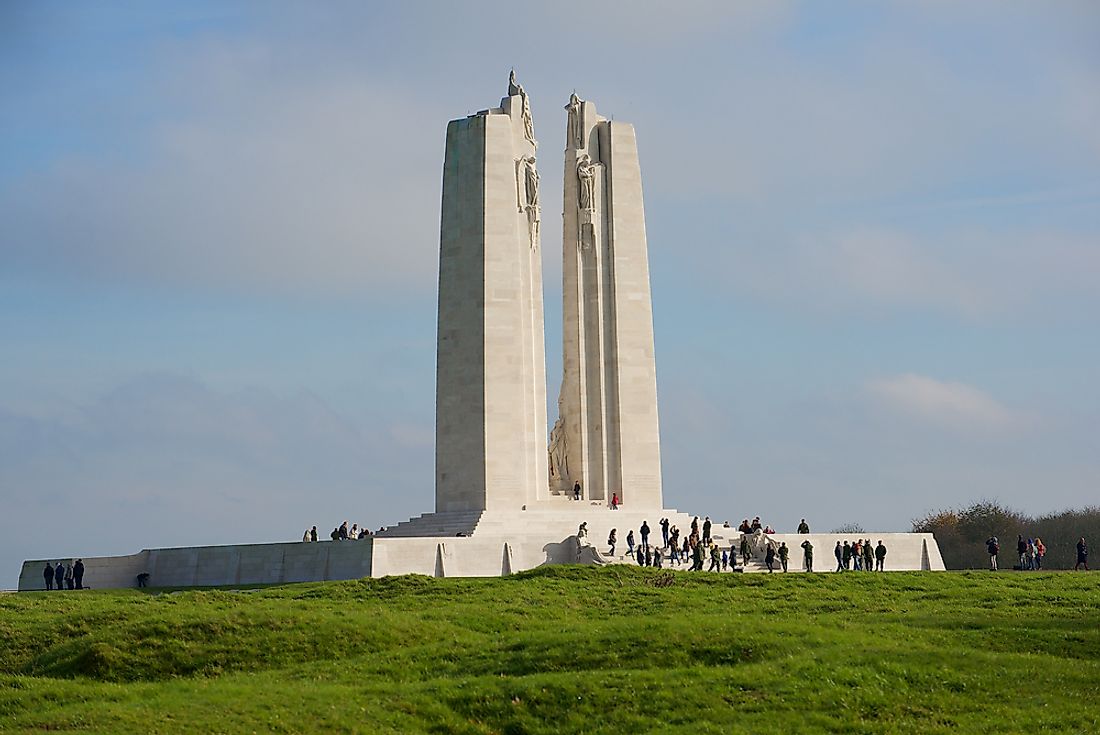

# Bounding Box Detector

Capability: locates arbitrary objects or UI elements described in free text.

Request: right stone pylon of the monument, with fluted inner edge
[549,94,663,509]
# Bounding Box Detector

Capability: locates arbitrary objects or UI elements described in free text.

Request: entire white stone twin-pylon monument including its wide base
[12,74,944,590]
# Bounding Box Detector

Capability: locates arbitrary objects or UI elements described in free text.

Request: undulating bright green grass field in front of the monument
[0,567,1100,735]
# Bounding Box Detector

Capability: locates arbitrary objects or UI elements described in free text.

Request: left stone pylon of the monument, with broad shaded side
[436,73,548,513]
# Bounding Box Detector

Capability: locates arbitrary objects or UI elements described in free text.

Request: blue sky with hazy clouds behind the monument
[0,1,1100,586]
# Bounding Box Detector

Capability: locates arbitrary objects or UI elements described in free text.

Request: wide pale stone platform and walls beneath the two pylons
[19,501,944,591]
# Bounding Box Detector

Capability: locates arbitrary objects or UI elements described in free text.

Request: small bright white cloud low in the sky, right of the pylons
[867,373,1022,430]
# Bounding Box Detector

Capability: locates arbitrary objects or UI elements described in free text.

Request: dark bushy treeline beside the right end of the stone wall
[913,501,1100,569]
